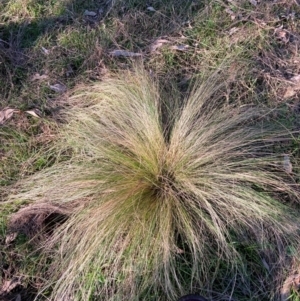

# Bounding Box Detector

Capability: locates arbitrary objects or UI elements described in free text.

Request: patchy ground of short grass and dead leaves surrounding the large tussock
[0,0,300,301]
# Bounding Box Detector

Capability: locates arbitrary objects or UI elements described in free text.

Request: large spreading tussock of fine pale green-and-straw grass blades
[14,70,299,301]
